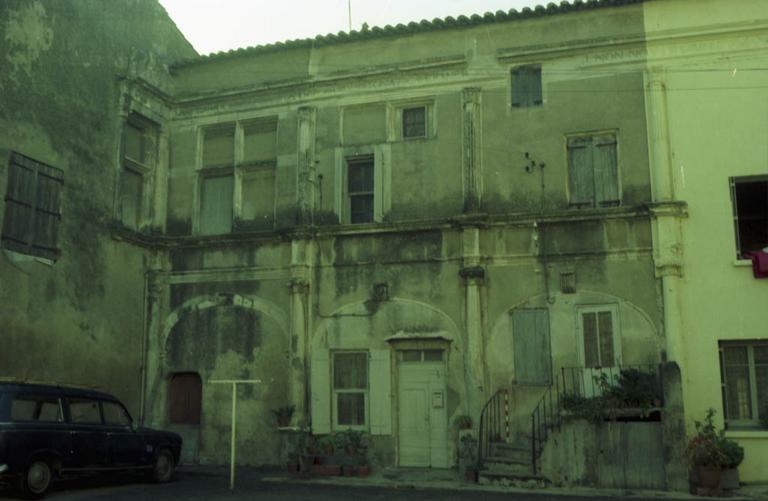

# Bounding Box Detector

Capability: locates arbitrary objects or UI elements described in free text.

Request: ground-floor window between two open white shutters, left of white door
[333,352,368,427]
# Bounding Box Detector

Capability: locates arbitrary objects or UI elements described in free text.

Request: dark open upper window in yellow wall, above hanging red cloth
[731,177,768,259]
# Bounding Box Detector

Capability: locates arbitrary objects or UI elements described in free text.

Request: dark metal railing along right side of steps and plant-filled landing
[531,365,663,474]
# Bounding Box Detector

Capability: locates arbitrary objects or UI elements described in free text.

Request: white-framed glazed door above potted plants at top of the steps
[576,305,621,367]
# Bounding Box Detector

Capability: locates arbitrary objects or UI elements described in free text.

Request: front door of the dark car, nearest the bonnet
[101,400,147,468]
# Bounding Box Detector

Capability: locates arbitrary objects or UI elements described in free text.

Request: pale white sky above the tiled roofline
[160,0,540,54]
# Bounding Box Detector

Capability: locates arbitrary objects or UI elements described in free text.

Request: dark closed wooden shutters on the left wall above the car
[0,151,64,261]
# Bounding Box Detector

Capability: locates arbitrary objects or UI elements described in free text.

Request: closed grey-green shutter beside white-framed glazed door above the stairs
[512,309,552,384]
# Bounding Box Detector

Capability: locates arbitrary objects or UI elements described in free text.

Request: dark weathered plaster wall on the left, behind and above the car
[0,0,195,416]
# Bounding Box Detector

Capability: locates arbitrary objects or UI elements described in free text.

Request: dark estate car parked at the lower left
[0,382,181,497]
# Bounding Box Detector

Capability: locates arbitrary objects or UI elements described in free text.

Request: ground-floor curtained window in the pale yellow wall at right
[720,341,768,426]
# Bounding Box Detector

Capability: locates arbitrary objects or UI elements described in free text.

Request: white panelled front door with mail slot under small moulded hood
[398,350,449,468]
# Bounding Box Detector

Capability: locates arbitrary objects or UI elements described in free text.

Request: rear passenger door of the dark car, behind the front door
[63,397,109,470]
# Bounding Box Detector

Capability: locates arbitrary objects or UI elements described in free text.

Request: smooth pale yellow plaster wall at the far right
[645,0,768,482]
